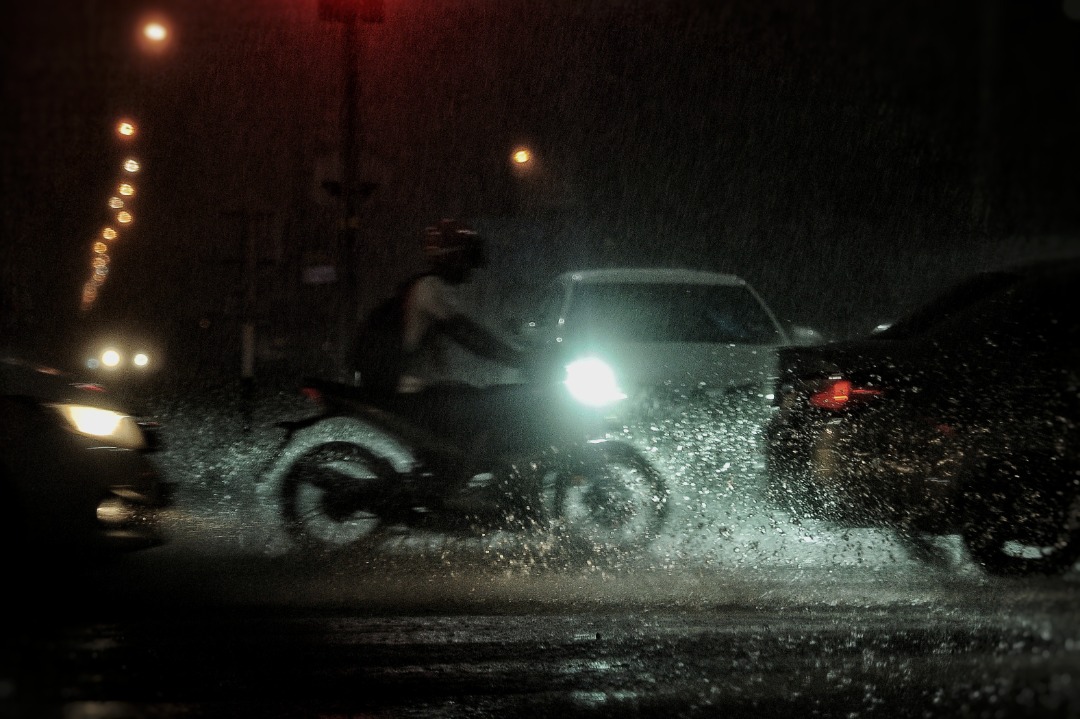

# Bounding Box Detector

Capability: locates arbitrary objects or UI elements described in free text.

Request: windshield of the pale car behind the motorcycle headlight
[566,282,781,344]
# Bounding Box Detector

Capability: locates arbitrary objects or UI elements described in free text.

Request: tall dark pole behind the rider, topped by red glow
[319,0,383,380]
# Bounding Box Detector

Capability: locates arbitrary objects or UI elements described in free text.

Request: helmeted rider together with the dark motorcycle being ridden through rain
[276,220,665,546]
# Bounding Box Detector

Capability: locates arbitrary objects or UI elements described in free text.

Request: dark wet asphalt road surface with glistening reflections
[8,551,1080,718]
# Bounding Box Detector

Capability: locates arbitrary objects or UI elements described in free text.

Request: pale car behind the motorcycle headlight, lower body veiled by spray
[507,267,812,490]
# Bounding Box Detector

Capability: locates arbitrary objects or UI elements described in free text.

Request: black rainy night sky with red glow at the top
[0,0,1080,369]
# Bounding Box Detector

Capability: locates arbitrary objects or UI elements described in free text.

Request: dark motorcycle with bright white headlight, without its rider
[260,356,667,555]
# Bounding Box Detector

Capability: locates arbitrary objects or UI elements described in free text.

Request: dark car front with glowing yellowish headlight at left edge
[0,349,172,559]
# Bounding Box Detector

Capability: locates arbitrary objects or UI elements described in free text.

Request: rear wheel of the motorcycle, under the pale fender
[281,442,396,551]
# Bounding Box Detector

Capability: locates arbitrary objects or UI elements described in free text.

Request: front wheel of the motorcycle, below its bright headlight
[542,443,667,555]
